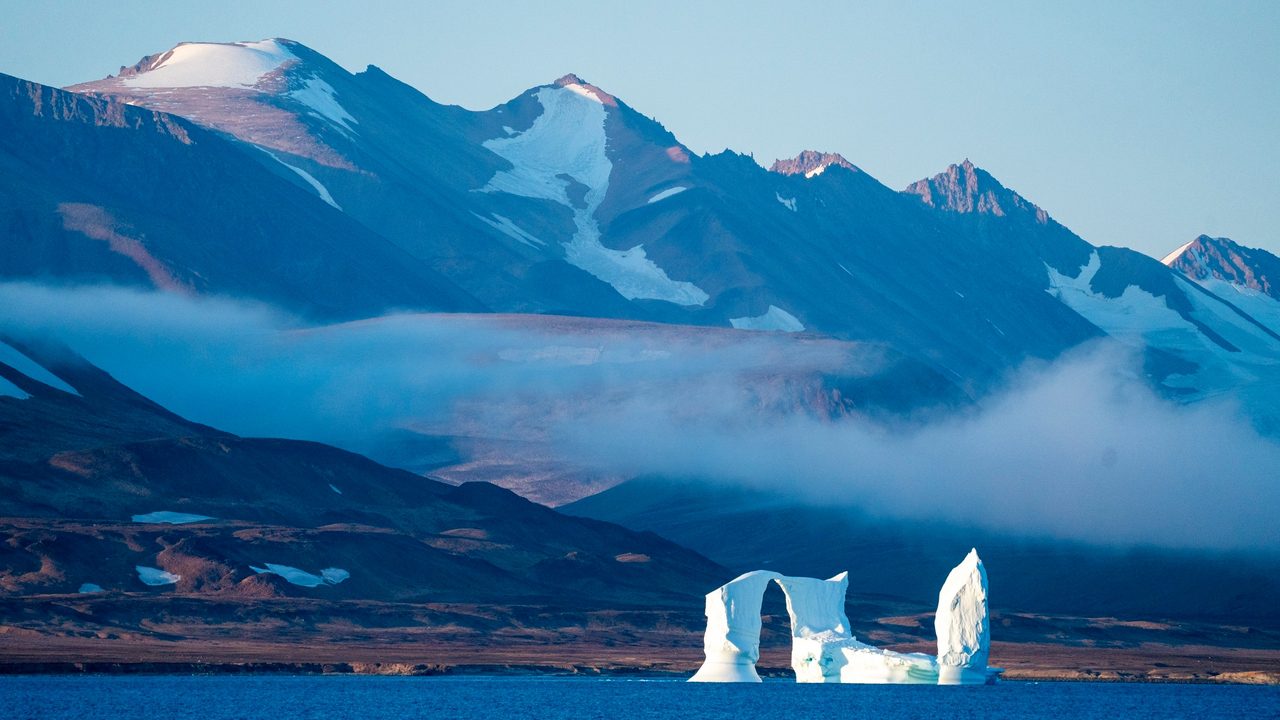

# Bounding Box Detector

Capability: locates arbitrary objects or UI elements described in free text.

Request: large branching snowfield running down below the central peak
[480,83,709,305]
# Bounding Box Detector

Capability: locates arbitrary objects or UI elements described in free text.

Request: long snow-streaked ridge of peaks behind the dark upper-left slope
[52,40,1280,415]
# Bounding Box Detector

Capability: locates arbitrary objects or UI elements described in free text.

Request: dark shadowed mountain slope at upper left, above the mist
[0,70,481,318]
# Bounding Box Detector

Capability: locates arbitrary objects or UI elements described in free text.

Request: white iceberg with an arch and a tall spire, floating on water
[690,550,1000,685]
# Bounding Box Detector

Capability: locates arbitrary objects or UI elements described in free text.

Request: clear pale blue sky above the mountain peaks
[0,0,1280,256]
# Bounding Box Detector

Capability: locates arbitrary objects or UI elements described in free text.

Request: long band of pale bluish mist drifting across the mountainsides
[0,283,1280,551]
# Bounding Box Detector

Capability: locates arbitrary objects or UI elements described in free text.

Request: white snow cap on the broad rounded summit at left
[122,40,298,87]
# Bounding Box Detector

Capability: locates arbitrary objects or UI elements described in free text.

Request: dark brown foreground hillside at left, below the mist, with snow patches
[0,338,723,609]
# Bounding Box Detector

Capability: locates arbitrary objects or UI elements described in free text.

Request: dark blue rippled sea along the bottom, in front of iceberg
[0,675,1280,720]
